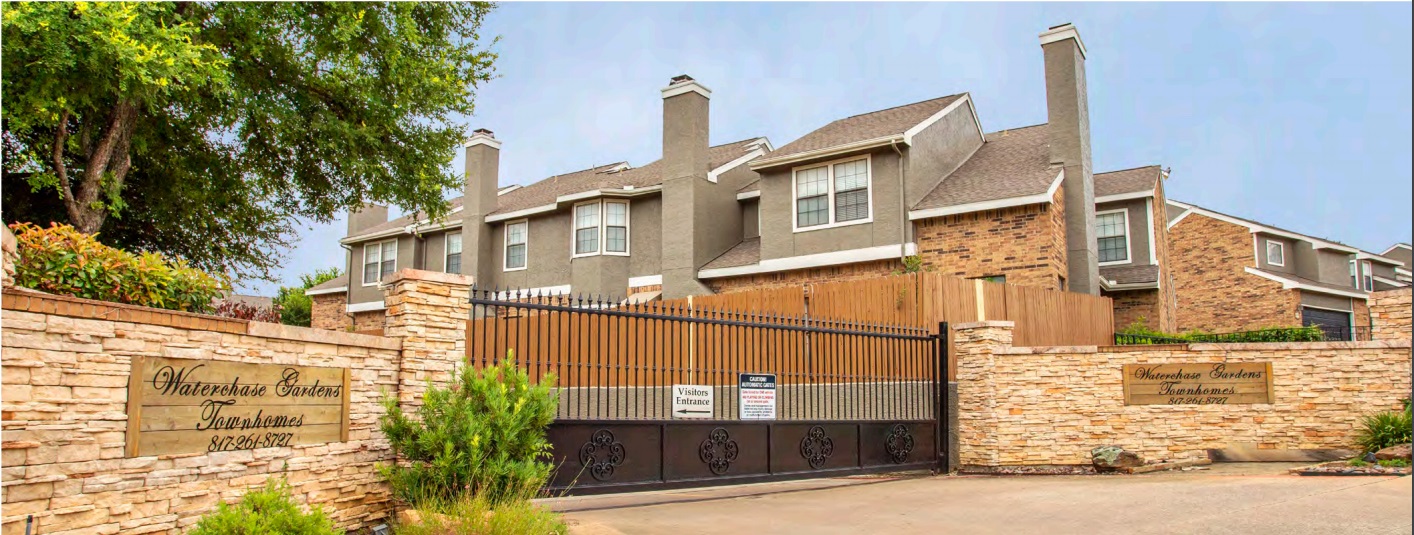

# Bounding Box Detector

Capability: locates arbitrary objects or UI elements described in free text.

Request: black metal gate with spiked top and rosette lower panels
[467,290,947,494]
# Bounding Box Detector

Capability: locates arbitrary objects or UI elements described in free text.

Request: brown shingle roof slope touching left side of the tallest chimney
[913,125,1061,209]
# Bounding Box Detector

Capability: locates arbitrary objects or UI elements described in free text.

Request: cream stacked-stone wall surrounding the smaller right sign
[954,321,1410,467]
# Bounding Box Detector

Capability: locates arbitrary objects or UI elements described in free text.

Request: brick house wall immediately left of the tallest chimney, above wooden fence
[913,188,1066,289]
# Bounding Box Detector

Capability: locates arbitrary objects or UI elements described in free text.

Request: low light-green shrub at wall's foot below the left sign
[187,478,344,535]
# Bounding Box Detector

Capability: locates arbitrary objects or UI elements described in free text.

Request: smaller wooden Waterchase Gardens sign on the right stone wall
[1124,362,1271,405]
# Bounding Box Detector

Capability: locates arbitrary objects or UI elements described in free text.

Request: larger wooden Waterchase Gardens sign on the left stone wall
[127,357,349,457]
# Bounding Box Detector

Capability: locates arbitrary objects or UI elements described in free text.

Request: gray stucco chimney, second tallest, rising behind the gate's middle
[662,75,713,299]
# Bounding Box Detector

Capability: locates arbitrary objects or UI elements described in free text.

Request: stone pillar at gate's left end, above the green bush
[383,269,471,409]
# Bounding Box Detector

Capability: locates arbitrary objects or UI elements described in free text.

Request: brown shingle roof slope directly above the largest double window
[771,93,963,159]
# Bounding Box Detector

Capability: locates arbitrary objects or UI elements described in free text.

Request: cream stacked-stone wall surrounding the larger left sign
[0,289,400,534]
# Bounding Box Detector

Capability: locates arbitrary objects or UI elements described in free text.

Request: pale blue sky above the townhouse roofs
[243,3,1414,294]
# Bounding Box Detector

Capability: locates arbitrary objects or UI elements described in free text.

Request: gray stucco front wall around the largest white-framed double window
[761,147,904,259]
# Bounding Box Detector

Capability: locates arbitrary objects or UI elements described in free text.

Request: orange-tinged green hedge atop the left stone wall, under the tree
[10,222,230,313]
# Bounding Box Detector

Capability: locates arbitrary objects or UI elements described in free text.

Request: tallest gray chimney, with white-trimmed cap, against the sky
[1041,23,1100,294]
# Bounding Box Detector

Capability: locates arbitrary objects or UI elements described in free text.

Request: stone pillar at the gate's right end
[950,321,1015,467]
